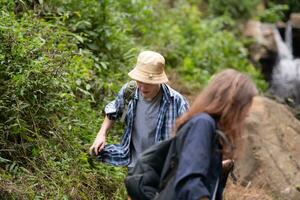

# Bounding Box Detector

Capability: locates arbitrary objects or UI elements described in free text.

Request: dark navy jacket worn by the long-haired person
[157,113,224,200]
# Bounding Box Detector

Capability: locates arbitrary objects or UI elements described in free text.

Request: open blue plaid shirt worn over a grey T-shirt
[97,83,188,166]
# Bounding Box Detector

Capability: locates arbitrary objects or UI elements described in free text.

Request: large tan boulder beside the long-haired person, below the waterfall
[236,97,300,200]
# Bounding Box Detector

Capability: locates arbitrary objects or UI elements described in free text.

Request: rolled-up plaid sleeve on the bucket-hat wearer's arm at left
[104,83,128,120]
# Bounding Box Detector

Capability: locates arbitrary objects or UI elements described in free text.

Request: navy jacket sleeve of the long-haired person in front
[174,116,215,200]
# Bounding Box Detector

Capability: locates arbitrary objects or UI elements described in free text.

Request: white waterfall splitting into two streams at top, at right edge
[270,22,300,105]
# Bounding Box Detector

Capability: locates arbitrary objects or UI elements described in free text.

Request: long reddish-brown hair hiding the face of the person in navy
[176,69,257,158]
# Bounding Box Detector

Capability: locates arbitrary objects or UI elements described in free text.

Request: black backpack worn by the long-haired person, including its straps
[125,120,233,200]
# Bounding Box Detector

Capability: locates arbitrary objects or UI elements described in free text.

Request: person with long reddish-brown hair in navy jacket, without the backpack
[158,69,257,200]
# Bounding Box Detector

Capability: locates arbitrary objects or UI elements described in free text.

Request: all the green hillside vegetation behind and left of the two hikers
[0,0,300,199]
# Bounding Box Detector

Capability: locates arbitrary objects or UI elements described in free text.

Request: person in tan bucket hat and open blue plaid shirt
[90,51,188,168]
